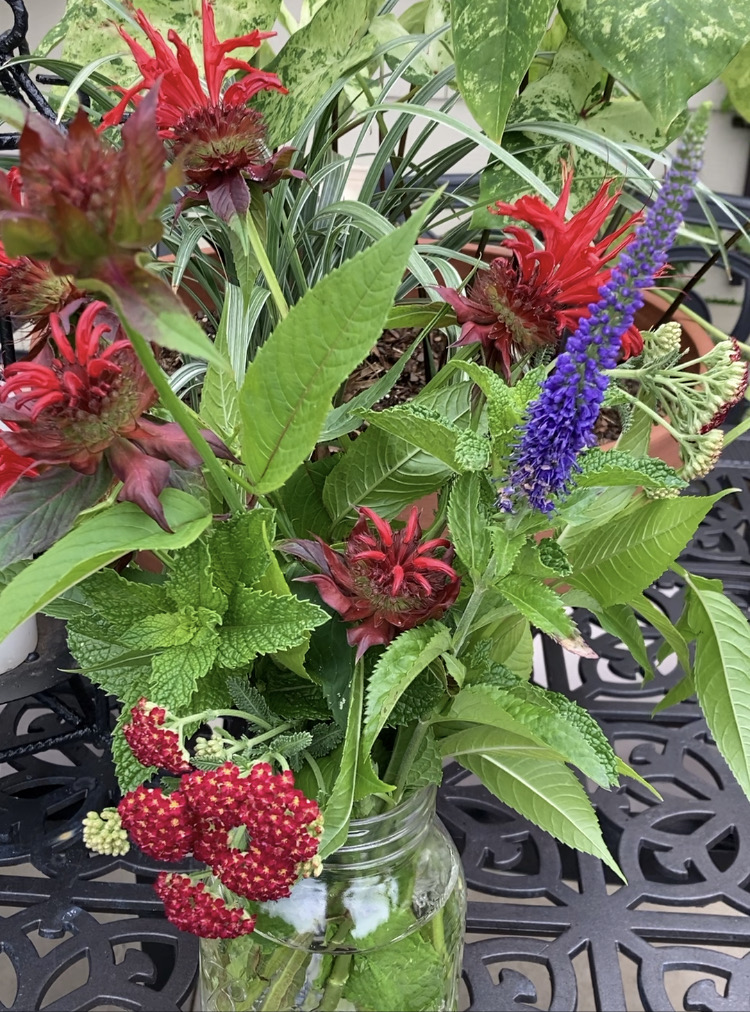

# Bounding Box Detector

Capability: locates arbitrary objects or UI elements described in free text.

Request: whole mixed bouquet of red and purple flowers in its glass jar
[0,0,750,1010]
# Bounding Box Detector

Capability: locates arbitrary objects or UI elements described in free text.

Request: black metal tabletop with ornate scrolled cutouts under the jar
[0,436,750,1012]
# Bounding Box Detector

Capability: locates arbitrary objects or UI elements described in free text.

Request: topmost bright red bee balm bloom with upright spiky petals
[102,0,302,218]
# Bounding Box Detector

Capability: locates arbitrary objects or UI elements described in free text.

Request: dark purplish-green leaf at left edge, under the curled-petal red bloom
[0,467,111,569]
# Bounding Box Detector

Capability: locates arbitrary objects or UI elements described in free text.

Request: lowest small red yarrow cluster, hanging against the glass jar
[154,871,256,938]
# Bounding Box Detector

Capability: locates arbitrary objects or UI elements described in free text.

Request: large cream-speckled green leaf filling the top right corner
[560,0,750,129]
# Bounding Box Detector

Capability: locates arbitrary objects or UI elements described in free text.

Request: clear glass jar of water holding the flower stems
[198,787,466,1012]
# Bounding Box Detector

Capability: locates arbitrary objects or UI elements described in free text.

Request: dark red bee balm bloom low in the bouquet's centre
[282,506,461,659]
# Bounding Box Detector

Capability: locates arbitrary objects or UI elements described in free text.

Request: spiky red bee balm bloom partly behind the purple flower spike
[437,170,643,380]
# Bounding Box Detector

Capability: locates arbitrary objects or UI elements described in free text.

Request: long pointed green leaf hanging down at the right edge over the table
[686,574,750,794]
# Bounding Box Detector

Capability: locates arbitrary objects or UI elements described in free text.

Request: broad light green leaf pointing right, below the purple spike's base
[564,490,728,607]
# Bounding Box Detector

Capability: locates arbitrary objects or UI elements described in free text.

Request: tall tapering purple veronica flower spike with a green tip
[498,108,709,513]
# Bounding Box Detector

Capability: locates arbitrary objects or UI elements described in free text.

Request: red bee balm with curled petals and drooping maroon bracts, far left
[0,302,233,530]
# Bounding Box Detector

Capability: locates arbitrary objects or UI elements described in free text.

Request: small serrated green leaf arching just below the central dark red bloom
[362,622,450,755]
